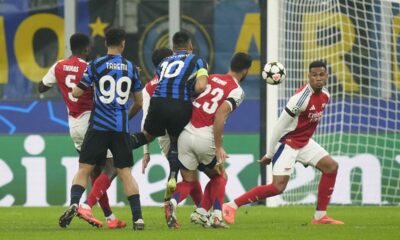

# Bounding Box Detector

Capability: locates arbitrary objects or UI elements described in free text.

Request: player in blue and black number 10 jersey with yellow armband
[133,32,208,199]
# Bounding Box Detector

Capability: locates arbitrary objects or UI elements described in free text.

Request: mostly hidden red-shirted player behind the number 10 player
[142,48,203,226]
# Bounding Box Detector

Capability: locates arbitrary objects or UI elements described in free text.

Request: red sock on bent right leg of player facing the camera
[317,171,337,211]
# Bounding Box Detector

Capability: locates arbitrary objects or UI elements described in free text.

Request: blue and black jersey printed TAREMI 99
[79,55,142,132]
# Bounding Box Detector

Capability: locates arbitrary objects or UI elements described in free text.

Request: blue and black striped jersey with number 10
[152,51,207,101]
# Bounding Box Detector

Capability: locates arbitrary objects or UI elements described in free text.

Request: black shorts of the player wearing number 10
[144,97,192,138]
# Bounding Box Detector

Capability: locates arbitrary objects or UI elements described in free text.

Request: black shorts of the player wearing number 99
[79,129,133,168]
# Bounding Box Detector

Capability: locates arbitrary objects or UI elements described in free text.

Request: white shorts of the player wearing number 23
[178,123,215,170]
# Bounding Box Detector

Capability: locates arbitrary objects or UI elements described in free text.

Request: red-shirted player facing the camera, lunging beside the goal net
[223,61,343,224]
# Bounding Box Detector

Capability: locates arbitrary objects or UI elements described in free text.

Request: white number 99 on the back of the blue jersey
[99,75,132,105]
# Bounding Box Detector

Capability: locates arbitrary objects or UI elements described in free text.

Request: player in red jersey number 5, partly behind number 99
[38,33,126,228]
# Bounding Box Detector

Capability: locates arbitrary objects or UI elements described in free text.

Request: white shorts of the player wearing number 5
[68,112,112,158]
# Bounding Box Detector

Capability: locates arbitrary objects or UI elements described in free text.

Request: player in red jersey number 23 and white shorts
[168,52,252,228]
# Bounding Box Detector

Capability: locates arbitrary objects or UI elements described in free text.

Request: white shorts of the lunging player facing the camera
[272,139,329,176]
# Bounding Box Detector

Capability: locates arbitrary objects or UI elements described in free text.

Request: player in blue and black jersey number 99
[60,28,144,230]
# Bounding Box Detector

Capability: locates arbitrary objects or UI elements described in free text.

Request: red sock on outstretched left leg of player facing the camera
[235,184,279,207]
